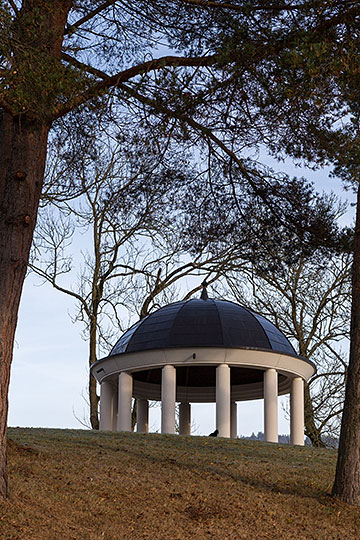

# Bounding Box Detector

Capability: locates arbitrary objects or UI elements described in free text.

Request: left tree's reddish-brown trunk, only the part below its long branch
[0,112,49,496]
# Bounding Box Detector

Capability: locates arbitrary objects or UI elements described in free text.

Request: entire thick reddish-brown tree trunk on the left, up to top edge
[0,0,72,497]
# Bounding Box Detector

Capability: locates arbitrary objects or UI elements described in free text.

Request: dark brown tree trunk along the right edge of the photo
[332,186,360,506]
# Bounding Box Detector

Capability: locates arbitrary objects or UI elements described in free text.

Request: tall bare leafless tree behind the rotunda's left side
[30,136,243,429]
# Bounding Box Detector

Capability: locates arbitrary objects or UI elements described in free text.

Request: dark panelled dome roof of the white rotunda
[109,298,297,356]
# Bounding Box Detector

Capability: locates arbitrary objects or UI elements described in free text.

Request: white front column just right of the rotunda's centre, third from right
[216,364,230,437]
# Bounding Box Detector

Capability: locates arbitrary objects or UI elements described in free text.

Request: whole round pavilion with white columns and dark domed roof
[91,286,315,445]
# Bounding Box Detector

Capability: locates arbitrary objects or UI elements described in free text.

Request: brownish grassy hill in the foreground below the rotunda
[0,428,360,540]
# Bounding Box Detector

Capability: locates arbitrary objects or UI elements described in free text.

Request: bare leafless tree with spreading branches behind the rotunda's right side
[219,254,352,446]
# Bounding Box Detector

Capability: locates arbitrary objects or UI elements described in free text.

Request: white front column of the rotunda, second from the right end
[264,369,279,442]
